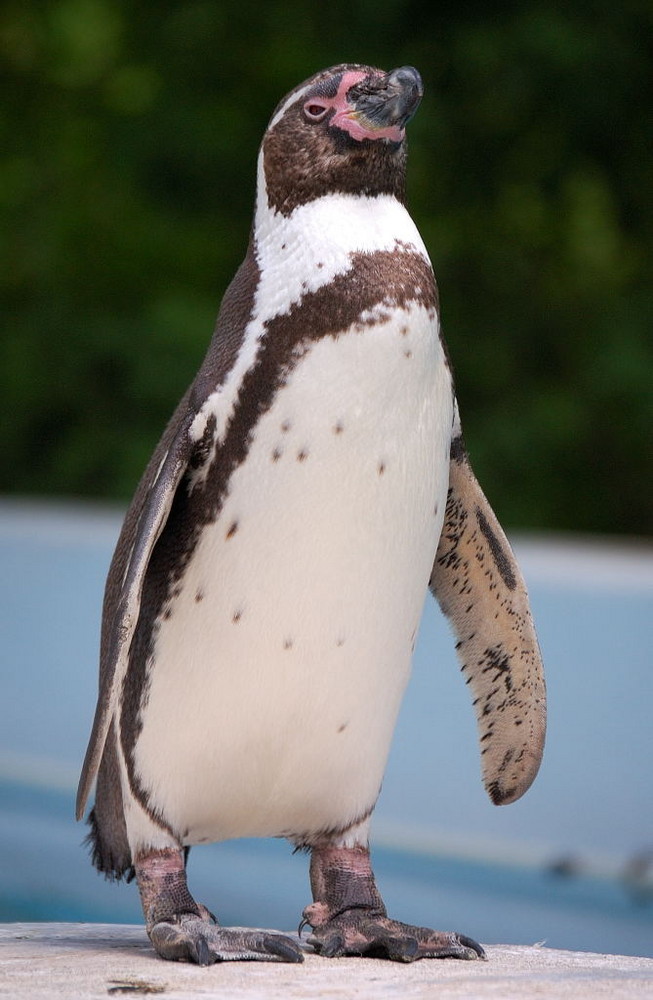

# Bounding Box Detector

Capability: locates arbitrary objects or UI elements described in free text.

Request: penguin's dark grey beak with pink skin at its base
[347,66,424,140]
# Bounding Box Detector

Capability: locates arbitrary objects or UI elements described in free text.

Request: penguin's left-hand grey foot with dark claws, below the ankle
[148,913,304,965]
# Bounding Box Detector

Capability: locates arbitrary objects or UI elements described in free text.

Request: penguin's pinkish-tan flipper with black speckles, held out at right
[429,434,546,805]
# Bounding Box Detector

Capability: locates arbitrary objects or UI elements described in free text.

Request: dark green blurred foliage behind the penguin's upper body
[0,0,653,533]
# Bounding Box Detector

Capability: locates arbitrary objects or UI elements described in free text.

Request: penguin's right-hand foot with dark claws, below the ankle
[304,906,485,962]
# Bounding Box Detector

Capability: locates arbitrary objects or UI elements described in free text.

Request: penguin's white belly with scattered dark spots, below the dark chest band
[126,305,452,844]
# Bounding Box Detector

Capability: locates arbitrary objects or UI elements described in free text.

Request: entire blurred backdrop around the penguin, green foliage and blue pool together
[0,0,653,954]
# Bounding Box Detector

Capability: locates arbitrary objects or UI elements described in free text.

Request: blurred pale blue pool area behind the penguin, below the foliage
[0,504,653,956]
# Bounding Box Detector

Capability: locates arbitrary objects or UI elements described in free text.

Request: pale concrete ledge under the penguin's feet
[0,923,653,1000]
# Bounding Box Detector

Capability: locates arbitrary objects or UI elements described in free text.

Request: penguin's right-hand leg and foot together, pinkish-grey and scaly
[302,845,485,962]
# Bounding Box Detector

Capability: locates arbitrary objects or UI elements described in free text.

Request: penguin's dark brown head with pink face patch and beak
[261,63,423,215]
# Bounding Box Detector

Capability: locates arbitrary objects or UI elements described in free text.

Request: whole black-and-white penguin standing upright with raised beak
[77,63,545,965]
